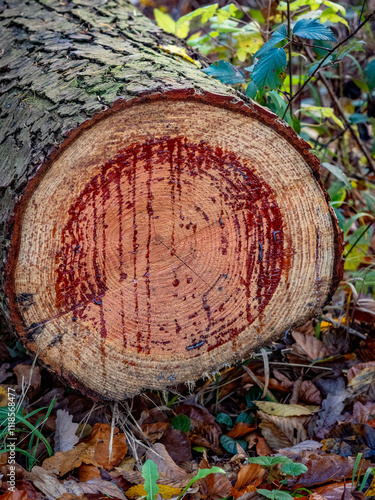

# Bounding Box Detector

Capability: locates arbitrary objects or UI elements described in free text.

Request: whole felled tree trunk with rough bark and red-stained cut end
[0,0,342,400]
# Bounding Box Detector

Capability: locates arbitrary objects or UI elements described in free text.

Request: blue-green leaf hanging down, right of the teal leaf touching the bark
[251,48,287,93]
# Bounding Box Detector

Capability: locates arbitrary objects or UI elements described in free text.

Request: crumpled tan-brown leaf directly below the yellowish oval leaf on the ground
[258,411,307,450]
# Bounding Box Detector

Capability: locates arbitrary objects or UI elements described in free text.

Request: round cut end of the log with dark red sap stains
[3,2,342,399]
